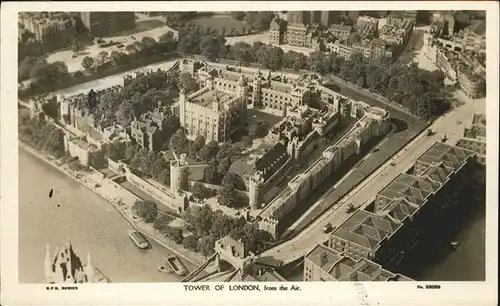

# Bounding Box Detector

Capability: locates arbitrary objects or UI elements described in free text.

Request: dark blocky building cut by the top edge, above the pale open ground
[80,11,135,37]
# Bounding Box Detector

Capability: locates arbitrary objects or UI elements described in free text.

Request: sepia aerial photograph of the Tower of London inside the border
[17,10,486,284]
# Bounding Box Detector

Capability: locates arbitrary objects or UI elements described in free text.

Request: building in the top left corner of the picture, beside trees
[19,12,76,52]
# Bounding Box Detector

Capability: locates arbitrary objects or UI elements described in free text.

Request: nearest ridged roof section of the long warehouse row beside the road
[331,210,399,250]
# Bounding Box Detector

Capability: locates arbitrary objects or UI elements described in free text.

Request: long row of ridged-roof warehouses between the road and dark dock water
[327,142,475,270]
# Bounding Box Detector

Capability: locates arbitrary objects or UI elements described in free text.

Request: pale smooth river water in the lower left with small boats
[19,148,193,283]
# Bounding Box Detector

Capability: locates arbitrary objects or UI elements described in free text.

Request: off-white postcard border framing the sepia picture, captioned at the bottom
[0,1,499,305]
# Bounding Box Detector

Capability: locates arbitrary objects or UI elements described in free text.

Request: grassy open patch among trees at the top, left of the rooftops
[191,15,256,36]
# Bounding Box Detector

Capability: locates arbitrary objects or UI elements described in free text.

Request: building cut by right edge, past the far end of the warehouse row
[457,114,486,164]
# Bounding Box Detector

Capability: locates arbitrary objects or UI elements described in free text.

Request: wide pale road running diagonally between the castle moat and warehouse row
[259,94,484,262]
